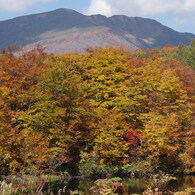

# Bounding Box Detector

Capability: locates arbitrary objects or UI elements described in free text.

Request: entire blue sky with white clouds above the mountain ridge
[0,0,195,34]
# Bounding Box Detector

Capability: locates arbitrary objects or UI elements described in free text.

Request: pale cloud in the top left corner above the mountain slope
[0,0,51,12]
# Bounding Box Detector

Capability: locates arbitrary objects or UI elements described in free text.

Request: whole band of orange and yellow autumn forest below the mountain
[0,41,195,183]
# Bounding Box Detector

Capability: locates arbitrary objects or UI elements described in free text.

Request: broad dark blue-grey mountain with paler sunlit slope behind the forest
[0,9,195,54]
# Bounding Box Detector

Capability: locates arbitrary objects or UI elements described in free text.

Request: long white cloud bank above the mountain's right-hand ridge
[86,0,195,16]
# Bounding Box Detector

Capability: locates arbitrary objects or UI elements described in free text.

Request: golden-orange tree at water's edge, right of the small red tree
[141,112,183,169]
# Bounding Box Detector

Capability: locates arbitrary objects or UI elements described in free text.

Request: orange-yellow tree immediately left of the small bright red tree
[94,109,130,164]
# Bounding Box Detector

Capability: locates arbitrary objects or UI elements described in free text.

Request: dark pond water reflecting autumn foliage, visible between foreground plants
[45,176,195,195]
